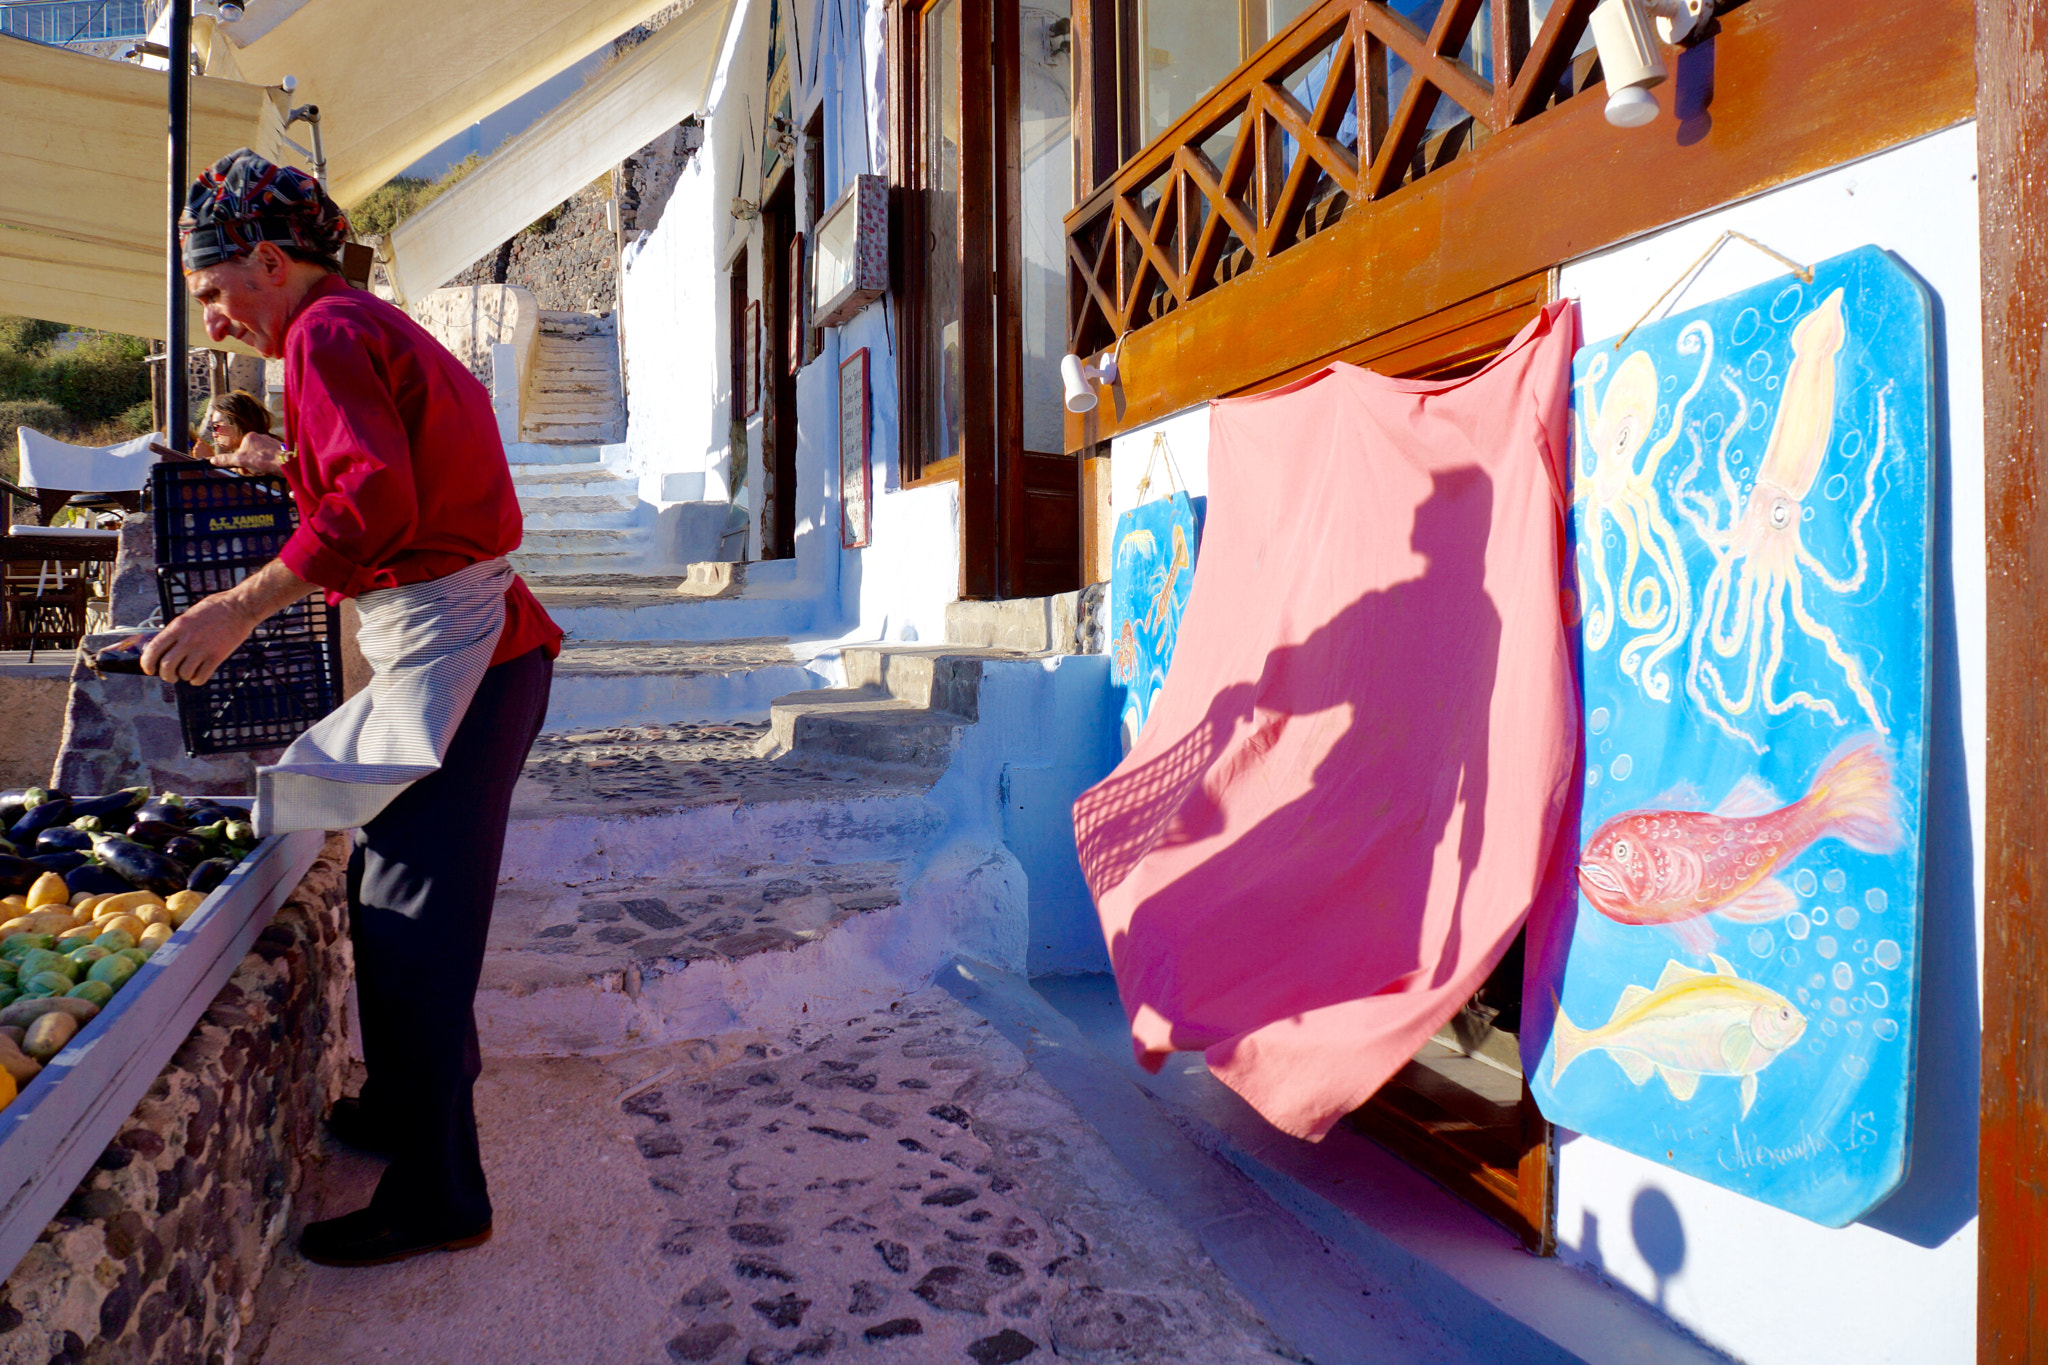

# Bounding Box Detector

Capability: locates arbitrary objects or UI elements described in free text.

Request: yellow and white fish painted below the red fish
[1550,954,1806,1117]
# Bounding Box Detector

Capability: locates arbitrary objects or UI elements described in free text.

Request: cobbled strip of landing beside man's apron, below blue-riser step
[514,722,903,817]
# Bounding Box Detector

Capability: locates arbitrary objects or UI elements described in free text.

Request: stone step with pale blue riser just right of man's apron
[547,636,836,731]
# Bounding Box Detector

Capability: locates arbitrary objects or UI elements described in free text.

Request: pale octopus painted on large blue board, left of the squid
[1575,323,1714,702]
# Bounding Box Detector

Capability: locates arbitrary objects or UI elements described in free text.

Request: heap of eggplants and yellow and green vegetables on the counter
[0,786,256,1109]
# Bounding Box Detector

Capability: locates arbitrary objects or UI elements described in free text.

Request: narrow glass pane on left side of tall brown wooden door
[924,0,963,460]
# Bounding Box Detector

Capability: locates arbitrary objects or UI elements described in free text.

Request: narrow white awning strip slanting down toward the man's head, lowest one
[385,0,739,301]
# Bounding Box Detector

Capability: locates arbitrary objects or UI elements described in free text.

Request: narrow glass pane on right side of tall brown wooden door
[1018,0,1073,452]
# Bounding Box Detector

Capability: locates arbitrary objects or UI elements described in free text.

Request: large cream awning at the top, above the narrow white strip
[221,0,679,207]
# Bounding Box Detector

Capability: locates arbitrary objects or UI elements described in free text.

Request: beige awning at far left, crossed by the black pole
[0,37,283,350]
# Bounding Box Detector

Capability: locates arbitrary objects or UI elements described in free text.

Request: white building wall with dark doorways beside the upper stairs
[621,0,961,641]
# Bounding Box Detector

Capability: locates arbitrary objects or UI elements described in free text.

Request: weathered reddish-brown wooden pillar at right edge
[1956,0,2048,1365]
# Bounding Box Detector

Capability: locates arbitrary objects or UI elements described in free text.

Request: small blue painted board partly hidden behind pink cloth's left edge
[1110,493,1202,751]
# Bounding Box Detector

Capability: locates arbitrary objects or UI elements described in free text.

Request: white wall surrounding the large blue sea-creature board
[1556,127,1987,1365]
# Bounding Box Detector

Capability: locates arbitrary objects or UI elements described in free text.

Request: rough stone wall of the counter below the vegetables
[0,835,352,1365]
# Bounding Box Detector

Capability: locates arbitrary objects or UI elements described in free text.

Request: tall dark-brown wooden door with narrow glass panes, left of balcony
[897,0,1081,598]
